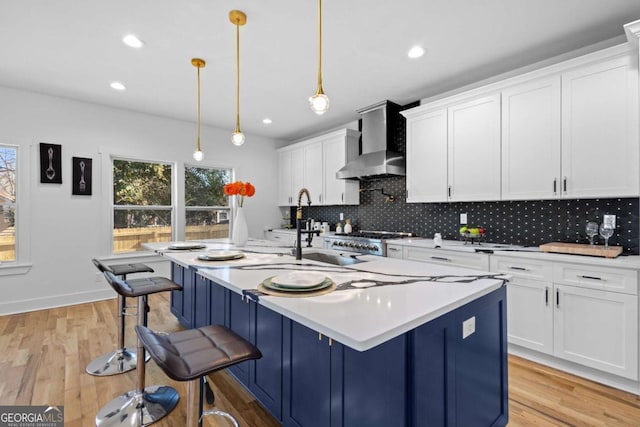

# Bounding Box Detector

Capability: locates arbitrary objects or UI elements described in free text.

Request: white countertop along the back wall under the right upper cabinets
[386,237,640,270]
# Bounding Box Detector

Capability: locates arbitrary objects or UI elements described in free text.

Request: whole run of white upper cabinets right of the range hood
[402,45,640,202]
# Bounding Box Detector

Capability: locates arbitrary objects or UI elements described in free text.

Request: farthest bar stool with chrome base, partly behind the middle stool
[86,258,153,376]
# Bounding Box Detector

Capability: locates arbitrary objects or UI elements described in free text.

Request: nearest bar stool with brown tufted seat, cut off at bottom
[136,325,262,427]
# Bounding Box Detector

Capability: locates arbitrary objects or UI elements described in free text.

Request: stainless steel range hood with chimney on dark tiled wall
[336,101,406,179]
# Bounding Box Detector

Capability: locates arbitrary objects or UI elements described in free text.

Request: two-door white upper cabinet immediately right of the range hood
[402,94,500,203]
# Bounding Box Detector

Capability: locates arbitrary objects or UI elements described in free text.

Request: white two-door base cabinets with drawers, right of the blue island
[491,254,638,380]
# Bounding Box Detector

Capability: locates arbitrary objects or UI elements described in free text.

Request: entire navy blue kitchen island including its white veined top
[156,241,508,427]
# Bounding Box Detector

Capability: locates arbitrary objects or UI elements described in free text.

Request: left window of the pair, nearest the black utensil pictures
[113,159,174,254]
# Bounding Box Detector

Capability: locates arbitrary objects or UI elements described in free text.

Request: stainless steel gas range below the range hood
[324,230,413,256]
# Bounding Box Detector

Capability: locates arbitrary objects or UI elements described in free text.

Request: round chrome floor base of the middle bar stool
[96,385,180,427]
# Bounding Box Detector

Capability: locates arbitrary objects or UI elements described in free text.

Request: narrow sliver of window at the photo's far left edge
[0,145,17,261]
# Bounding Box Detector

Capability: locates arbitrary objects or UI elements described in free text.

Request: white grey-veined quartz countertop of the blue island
[147,240,503,351]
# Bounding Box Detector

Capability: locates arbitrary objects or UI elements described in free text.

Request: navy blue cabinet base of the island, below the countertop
[171,264,508,427]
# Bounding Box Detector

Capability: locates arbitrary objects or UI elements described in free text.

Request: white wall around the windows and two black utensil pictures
[0,87,281,314]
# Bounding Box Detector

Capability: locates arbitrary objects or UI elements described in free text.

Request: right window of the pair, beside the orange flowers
[184,166,231,240]
